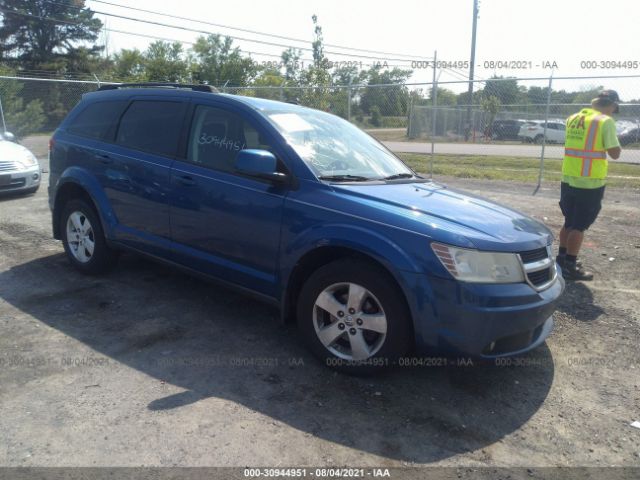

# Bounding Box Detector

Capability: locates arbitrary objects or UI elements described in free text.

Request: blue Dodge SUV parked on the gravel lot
[49,84,564,372]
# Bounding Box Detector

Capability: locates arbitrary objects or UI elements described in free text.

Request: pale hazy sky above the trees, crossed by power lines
[87,0,640,100]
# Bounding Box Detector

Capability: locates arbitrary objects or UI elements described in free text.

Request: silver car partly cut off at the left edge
[0,132,42,194]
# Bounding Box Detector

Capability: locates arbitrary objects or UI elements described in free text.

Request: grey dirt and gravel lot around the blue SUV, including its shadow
[0,160,640,467]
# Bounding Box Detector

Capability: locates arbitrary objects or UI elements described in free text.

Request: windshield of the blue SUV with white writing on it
[265,109,414,181]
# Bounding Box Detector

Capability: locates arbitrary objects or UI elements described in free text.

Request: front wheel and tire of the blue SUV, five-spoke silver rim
[297,259,413,374]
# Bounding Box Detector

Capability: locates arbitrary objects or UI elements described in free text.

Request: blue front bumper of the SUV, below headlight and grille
[404,275,564,358]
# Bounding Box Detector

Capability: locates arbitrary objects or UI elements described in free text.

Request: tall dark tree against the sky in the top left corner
[0,0,103,71]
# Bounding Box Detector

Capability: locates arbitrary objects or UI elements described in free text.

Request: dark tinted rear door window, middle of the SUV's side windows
[116,100,185,157]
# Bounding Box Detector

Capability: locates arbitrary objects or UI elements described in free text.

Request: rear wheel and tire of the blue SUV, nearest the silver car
[60,199,118,275]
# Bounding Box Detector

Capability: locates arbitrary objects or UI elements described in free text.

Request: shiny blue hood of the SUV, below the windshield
[334,182,553,251]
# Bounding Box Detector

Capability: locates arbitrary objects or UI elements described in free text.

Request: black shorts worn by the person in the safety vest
[560,182,604,232]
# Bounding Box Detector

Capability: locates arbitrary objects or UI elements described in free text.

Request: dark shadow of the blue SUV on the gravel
[0,254,554,463]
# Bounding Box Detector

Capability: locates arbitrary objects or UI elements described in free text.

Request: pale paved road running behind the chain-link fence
[382,142,640,164]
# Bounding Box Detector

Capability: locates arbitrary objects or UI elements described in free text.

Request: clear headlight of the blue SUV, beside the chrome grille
[431,242,524,283]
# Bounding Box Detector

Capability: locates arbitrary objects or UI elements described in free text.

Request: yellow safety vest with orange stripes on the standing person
[562,108,609,188]
